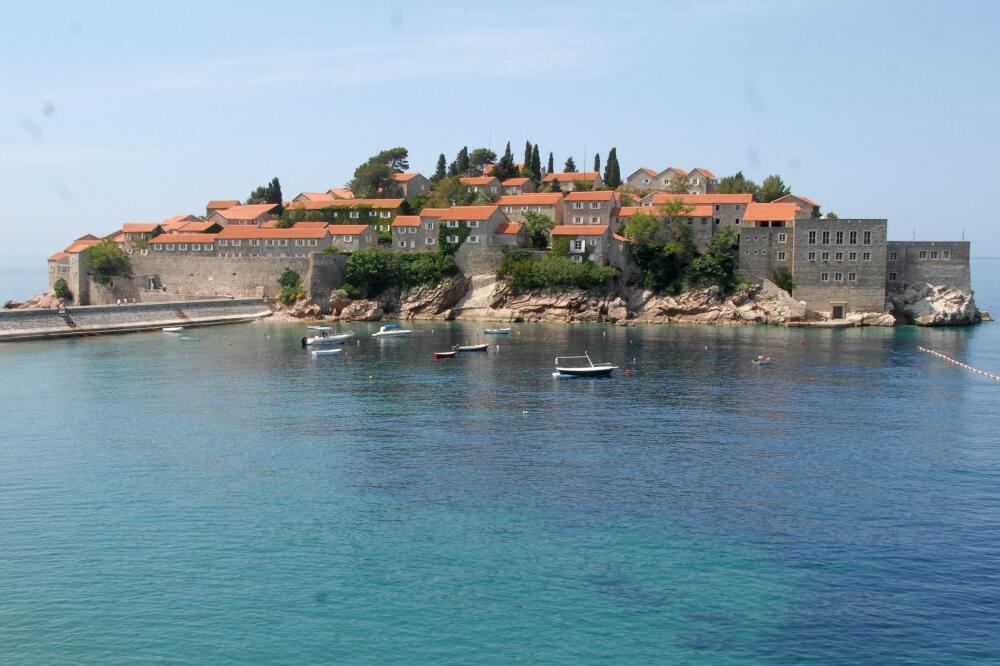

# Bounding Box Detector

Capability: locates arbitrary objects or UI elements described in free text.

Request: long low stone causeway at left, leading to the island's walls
[0,298,271,342]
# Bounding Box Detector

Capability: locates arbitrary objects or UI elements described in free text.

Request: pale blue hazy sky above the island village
[0,0,1000,298]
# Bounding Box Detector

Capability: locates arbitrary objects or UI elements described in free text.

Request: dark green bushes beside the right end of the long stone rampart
[346,248,458,298]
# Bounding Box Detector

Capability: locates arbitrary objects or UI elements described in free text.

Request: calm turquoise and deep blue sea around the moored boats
[0,259,1000,665]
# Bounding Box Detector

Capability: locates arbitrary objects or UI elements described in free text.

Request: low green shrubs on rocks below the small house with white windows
[497,250,618,292]
